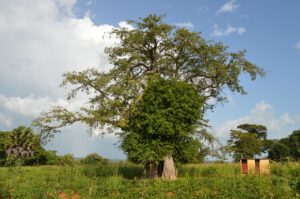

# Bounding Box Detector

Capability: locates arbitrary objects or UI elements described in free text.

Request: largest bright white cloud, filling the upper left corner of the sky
[0,0,116,96]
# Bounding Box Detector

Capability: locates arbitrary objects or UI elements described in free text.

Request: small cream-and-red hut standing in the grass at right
[240,159,270,175]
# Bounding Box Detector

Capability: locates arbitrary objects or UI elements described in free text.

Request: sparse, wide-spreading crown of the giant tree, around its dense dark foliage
[33,15,265,176]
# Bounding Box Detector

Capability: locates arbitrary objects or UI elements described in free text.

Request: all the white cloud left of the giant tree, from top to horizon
[0,0,125,158]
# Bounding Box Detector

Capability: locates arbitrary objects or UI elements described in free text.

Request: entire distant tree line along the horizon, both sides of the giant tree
[0,124,300,166]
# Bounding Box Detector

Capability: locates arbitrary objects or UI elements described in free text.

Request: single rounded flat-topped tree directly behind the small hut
[227,124,268,161]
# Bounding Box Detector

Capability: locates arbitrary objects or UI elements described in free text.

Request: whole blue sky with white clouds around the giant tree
[0,0,300,159]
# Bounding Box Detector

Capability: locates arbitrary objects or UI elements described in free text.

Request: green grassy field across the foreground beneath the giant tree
[0,163,300,199]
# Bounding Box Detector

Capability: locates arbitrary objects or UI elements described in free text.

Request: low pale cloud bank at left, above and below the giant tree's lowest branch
[0,95,125,159]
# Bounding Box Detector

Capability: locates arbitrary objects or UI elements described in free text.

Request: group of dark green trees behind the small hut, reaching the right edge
[224,124,300,161]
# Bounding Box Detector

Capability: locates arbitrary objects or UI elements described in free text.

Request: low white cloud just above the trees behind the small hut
[215,101,300,139]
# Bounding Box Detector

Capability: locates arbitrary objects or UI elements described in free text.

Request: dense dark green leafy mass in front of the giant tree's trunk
[121,79,203,163]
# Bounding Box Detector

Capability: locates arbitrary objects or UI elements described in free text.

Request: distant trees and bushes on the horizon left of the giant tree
[0,126,108,166]
